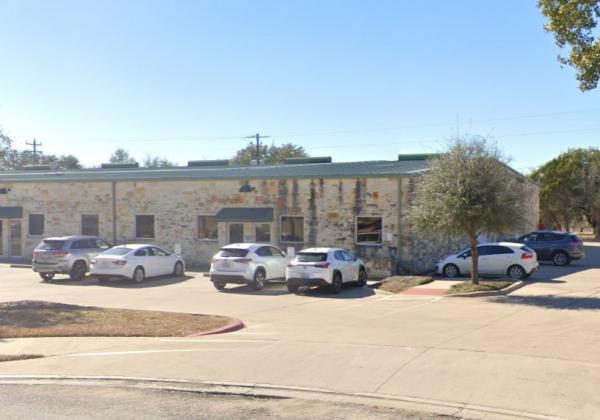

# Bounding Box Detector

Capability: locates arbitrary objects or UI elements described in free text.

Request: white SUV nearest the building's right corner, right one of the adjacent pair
[285,248,367,293]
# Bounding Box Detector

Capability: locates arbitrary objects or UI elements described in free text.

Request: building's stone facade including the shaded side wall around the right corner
[0,166,539,276]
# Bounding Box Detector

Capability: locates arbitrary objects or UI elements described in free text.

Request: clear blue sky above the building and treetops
[0,0,600,171]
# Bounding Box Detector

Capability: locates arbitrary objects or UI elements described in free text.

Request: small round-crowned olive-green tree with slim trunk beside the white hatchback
[410,136,526,284]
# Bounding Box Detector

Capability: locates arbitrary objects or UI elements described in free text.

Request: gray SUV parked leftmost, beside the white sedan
[32,236,111,281]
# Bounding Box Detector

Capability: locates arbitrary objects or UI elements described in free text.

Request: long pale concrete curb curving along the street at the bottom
[0,375,566,420]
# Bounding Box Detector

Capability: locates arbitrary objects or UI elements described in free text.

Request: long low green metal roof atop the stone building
[0,159,428,184]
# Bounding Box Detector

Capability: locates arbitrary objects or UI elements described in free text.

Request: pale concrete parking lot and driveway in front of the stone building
[0,243,600,418]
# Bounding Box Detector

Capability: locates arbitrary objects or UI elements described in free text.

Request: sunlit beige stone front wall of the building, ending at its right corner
[0,178,398,275]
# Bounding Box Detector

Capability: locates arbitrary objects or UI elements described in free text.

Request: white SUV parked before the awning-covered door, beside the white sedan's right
[208,243,288,290]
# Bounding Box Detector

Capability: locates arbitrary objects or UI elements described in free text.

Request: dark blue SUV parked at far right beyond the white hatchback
[519,230,585,266]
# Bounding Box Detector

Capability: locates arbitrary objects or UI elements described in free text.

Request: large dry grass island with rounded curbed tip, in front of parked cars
[0,301,231,338]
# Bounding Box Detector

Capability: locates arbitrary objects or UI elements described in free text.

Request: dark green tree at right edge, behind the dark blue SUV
[531,148,600,236]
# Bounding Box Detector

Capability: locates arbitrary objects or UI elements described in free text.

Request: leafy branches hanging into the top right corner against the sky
[538,0,600,91]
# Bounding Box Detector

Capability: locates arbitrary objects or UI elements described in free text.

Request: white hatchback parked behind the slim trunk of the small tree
[435,242,539,280]
